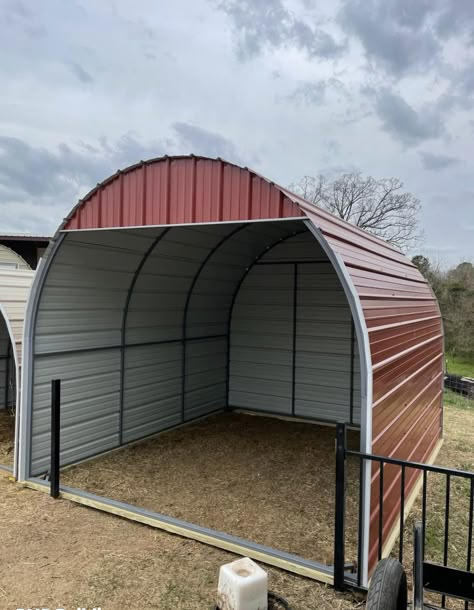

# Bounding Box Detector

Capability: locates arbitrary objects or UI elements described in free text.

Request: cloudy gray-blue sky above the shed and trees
[0,0,474,264]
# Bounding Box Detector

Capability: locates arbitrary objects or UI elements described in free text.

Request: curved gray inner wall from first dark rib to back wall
[123,223,300,442]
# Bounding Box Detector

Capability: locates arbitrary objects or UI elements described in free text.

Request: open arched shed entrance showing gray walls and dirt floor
[24,220,368,578]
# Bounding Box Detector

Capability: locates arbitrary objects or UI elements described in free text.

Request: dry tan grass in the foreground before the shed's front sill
[0,478,360,610]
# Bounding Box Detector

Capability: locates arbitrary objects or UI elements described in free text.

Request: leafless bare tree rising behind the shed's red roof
[290,173,421,250]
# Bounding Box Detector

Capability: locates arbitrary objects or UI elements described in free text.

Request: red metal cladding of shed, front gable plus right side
[62,156,443,565]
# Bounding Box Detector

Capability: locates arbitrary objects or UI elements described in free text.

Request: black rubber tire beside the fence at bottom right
[365,558,408,610]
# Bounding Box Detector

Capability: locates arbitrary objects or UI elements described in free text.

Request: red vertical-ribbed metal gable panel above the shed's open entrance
[63,157,303,230]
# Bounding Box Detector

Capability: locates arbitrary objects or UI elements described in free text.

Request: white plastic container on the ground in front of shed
[217,557,268,610]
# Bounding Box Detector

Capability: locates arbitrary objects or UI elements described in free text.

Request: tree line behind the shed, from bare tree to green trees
[290,172,474,358]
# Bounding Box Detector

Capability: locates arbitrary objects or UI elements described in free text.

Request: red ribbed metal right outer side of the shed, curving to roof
[301,202,443,566]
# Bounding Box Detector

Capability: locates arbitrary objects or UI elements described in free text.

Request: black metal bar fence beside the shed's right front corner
[334,424,474,608]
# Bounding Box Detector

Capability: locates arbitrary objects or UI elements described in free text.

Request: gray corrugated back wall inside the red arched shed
[229,233,360,424]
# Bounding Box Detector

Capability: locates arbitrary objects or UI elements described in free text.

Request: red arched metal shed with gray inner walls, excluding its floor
[15,156,443,576]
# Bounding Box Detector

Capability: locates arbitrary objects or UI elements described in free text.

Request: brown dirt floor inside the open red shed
[62,414,358,564]
